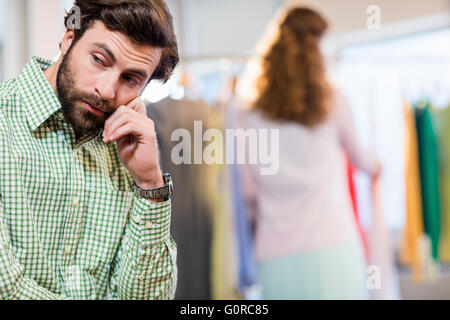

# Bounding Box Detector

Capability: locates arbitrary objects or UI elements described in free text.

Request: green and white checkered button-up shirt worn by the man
[0,58,177,299]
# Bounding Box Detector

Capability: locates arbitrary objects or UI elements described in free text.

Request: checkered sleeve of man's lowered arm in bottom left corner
[0,197,70,300]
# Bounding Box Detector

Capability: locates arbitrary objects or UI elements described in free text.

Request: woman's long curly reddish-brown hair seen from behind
[253,8,331,127]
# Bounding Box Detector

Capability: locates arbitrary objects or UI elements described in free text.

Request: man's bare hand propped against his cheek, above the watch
[103,97,164,189]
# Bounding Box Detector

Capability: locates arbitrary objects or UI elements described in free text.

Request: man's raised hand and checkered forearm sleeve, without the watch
[103,97,177,300]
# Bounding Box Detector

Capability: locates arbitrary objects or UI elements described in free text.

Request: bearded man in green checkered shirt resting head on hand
[0,0,179,299]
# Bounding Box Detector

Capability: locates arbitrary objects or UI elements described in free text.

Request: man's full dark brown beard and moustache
[56,45,114,139]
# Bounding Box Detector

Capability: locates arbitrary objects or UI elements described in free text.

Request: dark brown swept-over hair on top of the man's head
[64,0,180,82]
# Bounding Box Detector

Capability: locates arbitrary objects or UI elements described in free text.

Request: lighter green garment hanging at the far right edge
[431,106,450,262]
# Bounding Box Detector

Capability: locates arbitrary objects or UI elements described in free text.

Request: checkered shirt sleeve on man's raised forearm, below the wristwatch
[109,196,178,300]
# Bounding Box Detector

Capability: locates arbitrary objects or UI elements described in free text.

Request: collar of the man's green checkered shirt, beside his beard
[17,57,61,131]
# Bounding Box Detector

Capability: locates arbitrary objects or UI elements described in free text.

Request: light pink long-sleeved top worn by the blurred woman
[238,89,377,261]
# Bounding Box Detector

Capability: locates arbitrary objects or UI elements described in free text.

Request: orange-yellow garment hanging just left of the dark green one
[400,103,424,282]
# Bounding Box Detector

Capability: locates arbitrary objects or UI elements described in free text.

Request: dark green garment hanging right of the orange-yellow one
[415,104,441,260]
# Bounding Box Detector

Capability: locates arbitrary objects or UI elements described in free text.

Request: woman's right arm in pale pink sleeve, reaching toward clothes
[336,91,377,174]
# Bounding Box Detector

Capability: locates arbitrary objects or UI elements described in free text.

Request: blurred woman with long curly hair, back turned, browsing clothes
[237,8,380,299]
